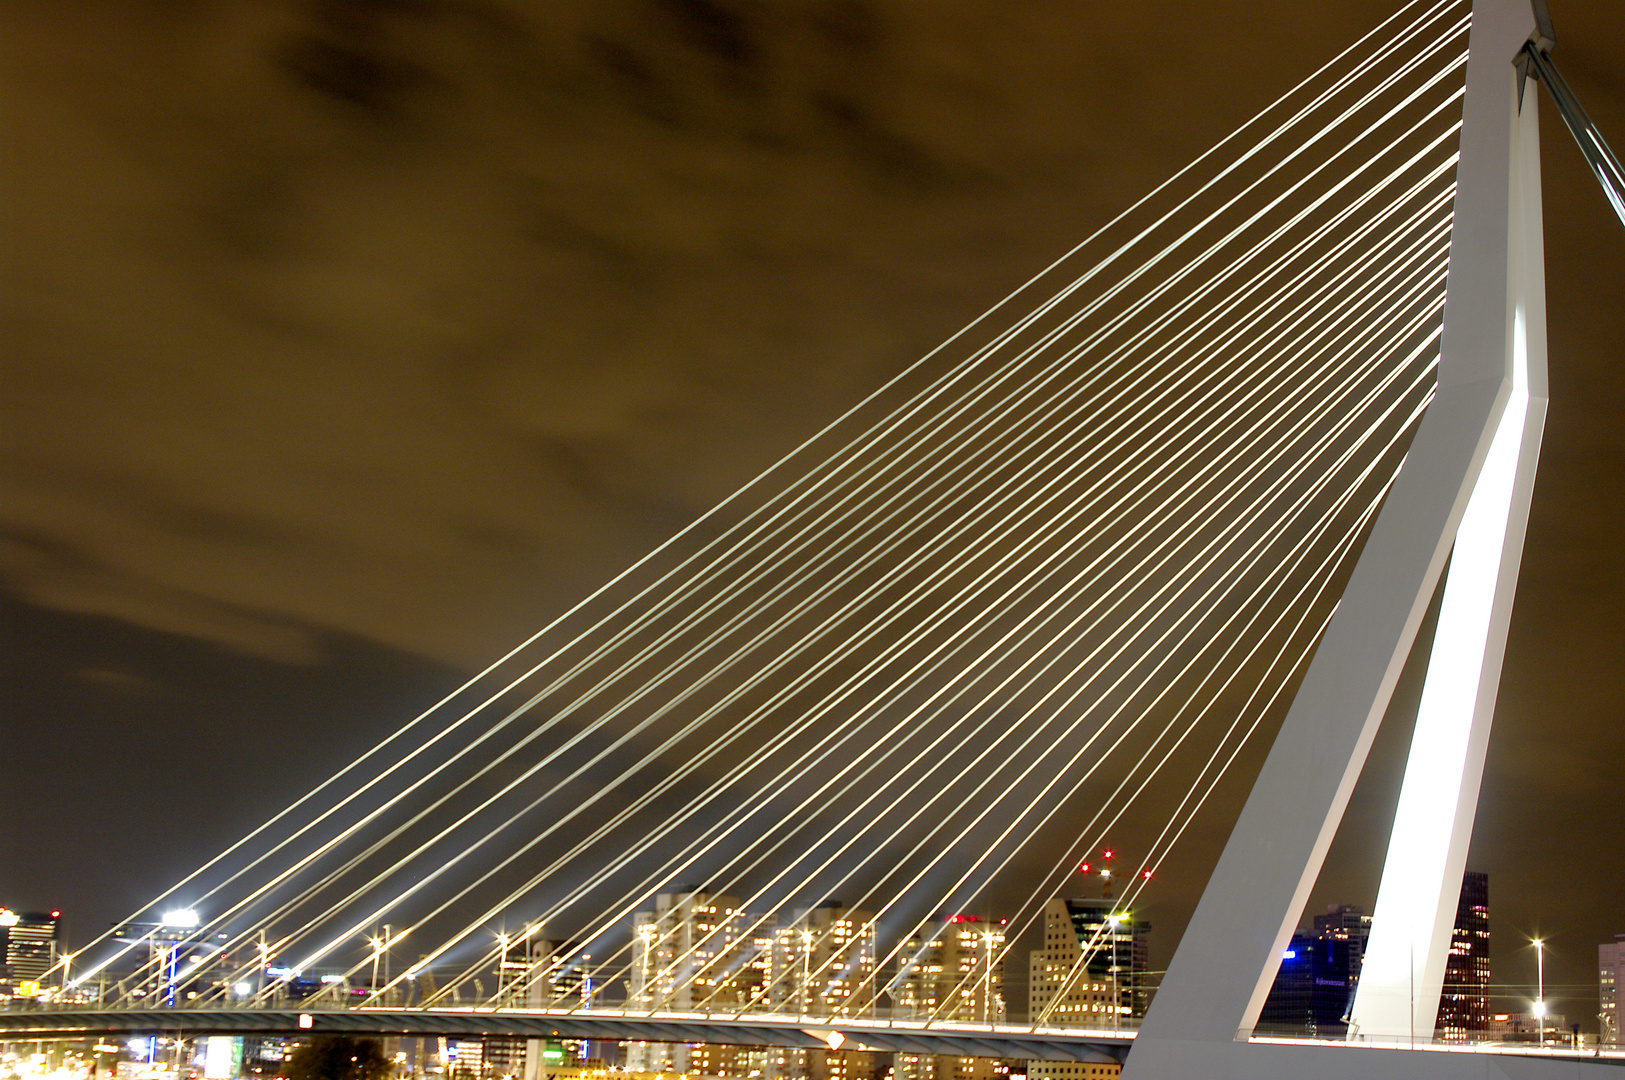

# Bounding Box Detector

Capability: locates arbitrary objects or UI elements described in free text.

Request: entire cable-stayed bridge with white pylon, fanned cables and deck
[0,0,1619,1077]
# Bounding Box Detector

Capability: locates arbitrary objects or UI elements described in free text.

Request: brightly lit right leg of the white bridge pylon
[1350,69,1545,1041]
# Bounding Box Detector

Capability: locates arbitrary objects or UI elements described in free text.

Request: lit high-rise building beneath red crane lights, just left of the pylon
[1027,896,1151,1080]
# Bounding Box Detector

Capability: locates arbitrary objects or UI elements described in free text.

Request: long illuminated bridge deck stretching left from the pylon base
[0,1009,1134,1064]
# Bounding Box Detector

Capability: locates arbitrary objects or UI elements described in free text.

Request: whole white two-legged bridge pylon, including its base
[1125,0,1599,1080]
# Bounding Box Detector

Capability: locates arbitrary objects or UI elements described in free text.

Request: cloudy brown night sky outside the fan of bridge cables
[9,0,1625,1028]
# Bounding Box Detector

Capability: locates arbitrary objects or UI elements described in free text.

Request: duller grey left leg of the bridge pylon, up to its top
[1125,0,1545,1080]
